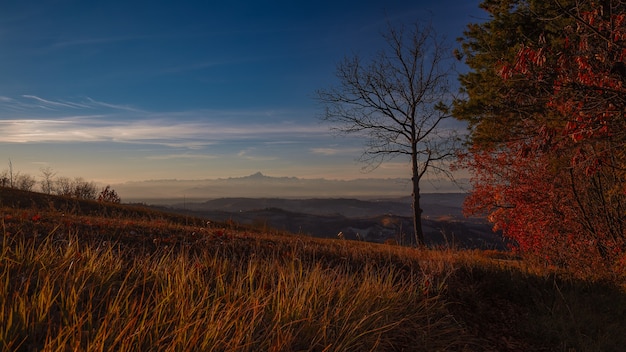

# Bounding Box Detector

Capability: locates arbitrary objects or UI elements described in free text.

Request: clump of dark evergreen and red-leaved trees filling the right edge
[455,0,626,270]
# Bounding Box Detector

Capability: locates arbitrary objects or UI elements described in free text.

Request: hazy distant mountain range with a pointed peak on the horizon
[112,172,464,203]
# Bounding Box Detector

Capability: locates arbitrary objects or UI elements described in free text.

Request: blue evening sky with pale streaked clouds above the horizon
[0,0,485,184]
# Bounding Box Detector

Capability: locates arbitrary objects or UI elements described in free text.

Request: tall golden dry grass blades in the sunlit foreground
[0,226,469,351]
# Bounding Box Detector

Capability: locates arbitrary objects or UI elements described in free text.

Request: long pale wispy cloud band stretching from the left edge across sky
[0,95,328,149]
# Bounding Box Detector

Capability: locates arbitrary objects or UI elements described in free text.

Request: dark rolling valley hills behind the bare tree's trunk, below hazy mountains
[161,193,506,249]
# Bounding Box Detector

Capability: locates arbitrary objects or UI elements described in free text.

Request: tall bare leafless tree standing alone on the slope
[317,23,458,245]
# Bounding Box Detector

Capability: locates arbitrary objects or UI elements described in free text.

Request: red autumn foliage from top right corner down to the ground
[461,1,626,276]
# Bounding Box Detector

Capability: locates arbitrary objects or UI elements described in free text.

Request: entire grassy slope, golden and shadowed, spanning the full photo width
[0,189,626,351]
